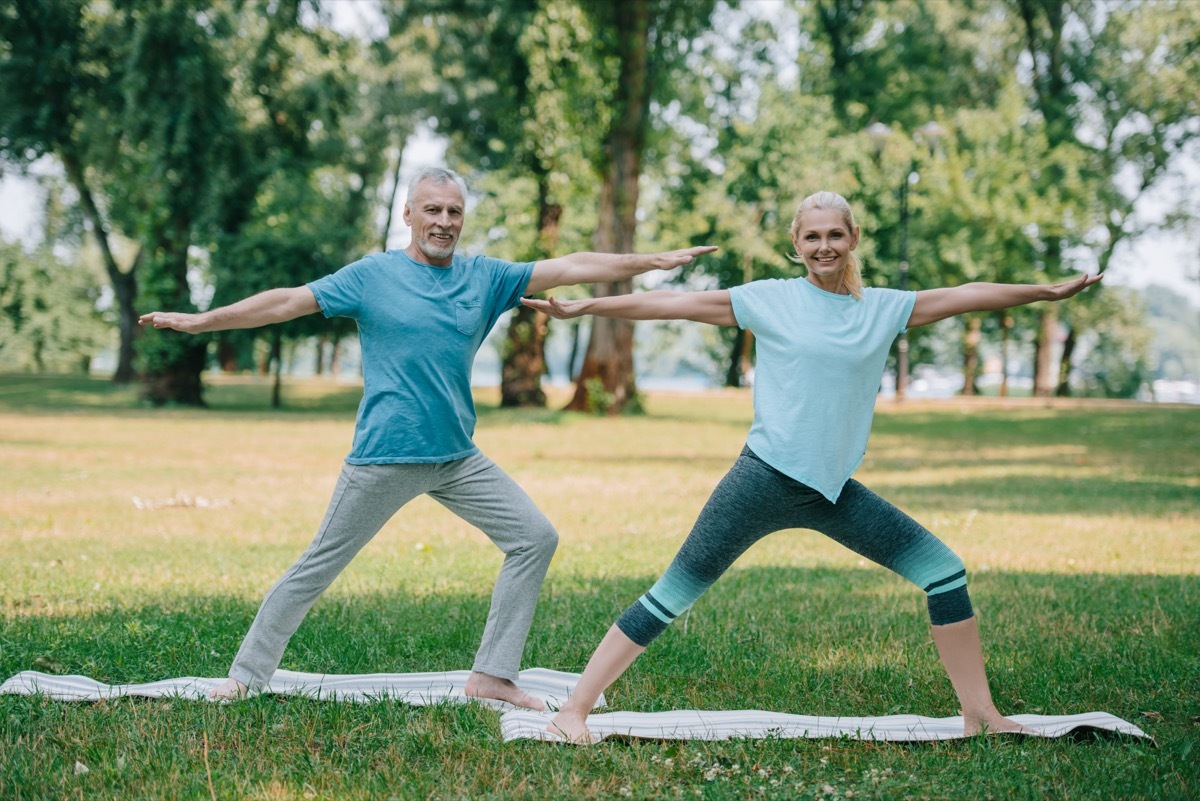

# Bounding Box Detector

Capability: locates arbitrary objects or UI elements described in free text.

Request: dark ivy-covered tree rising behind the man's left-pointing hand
[114,0,243,405]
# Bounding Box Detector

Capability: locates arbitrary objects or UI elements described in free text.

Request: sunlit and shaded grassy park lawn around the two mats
[0,377,1200,800]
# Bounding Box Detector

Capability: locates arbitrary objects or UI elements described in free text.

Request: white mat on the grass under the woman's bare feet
[500,710,1152,741]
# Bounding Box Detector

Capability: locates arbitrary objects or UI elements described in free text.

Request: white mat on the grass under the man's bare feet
[0,668,604,709]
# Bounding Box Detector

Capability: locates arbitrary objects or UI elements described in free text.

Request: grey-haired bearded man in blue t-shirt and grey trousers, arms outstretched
[140,168,715,710]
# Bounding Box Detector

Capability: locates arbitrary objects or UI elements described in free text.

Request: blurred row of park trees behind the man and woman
[0,0,1200,414]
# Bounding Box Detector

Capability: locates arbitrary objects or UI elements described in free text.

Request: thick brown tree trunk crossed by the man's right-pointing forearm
[566,0,650,415]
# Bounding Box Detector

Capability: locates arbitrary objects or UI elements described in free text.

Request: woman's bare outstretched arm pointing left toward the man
[521,289,738,325]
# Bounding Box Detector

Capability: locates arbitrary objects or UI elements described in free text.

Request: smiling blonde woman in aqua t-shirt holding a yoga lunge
[523,192,1100,742]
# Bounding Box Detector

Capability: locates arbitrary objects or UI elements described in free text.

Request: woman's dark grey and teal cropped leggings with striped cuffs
[617,447,973,646]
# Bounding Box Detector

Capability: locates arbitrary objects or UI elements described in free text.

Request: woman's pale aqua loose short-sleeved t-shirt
[730,278,917,502]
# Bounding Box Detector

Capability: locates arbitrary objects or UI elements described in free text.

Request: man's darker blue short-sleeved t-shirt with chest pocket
[308,251,533,464]
